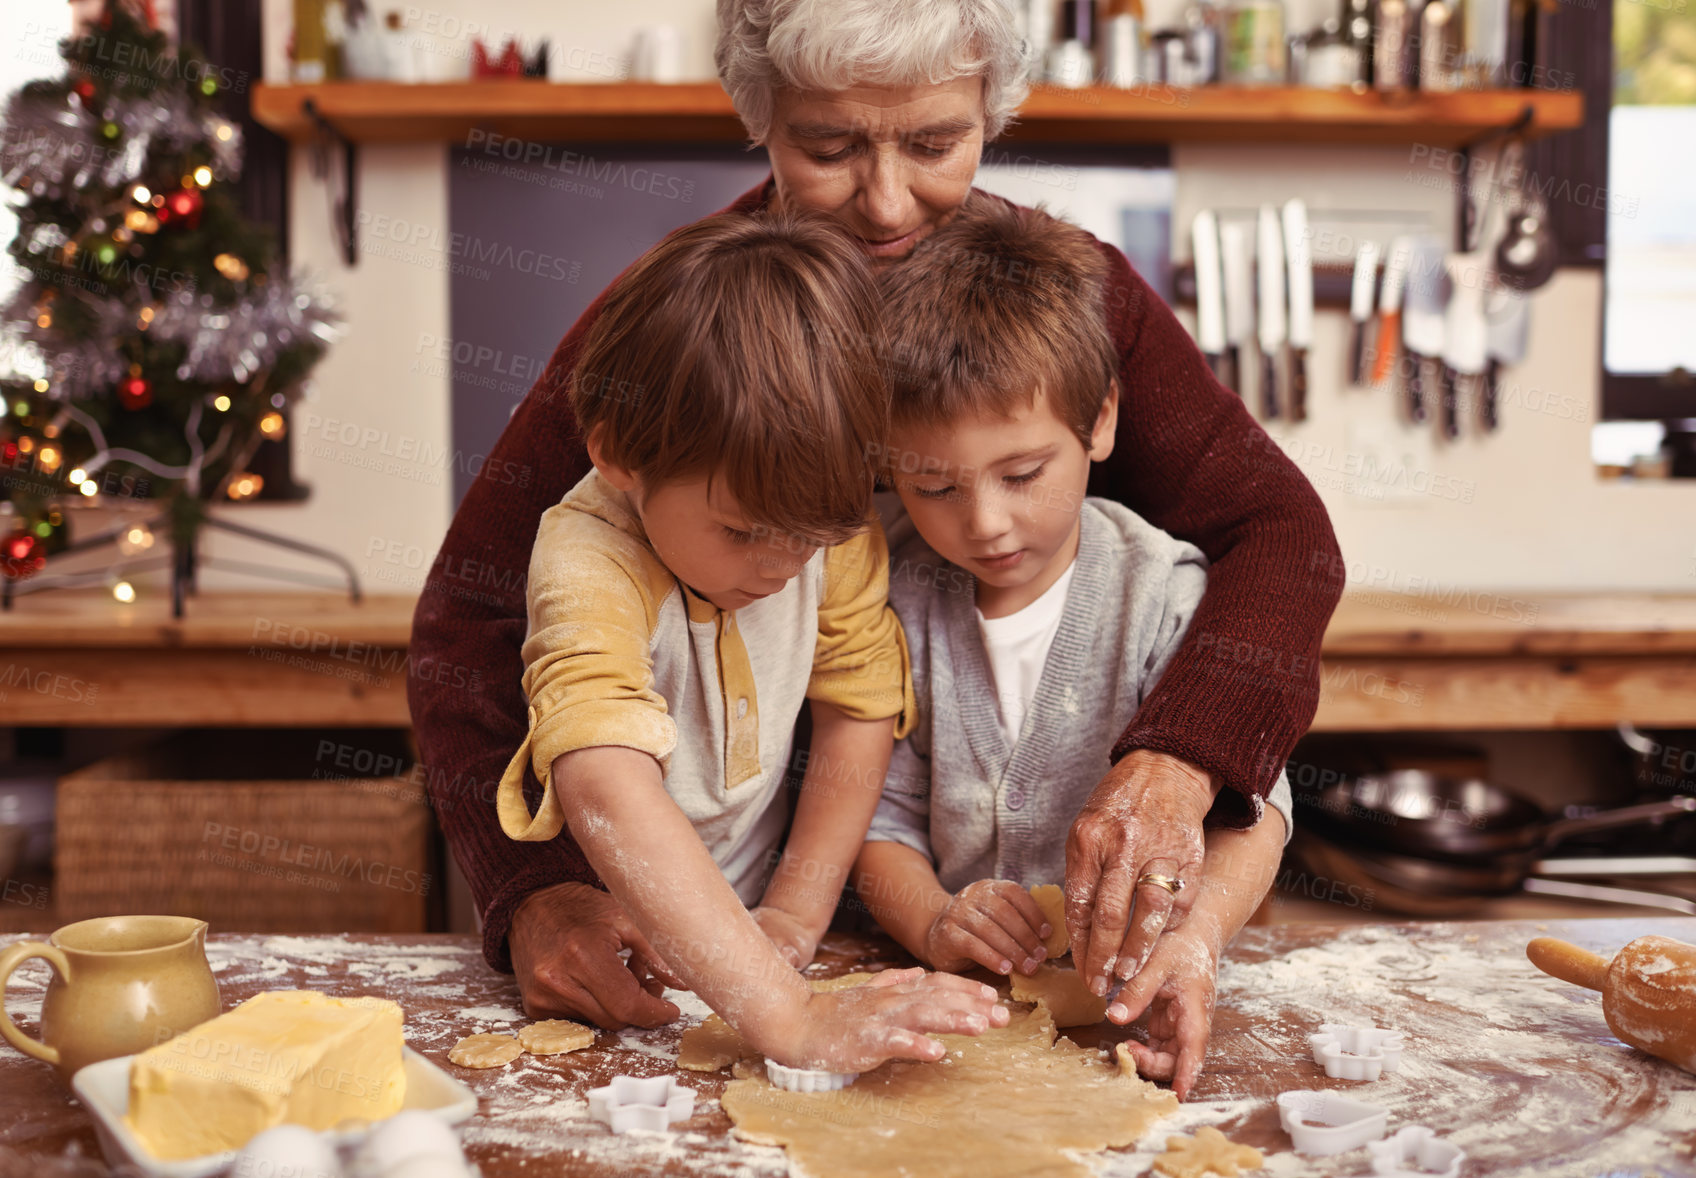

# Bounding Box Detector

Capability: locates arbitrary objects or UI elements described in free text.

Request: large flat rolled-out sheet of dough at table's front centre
[722,1007,1177,1178]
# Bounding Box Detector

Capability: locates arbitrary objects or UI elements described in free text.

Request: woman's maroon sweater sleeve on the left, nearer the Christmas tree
[407,180,770,973]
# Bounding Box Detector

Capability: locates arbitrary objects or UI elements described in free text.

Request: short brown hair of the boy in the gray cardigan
[879,193,1119,449]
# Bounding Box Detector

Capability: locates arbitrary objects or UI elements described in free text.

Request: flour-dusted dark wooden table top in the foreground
[0,917,1696,1178]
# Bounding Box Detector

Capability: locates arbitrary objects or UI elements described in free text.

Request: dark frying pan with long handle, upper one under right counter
[1296,770,1696,861]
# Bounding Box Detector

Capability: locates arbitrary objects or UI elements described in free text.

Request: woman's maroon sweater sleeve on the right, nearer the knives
[1091,244,1343,827]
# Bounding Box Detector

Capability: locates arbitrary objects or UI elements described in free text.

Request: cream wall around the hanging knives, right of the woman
[1174,144,1696,592]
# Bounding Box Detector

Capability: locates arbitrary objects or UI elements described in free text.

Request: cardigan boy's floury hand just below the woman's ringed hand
[1107,920,1219,1100]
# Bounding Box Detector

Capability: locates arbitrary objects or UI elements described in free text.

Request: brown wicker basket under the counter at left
[54,731,438,932]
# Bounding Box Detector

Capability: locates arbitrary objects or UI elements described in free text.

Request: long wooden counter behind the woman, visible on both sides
[0,586,1696,732]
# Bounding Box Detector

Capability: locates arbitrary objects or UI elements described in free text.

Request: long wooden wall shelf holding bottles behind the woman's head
[253,81,1584,147]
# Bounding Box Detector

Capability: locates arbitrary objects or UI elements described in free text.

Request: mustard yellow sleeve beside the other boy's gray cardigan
[807,522,916,737]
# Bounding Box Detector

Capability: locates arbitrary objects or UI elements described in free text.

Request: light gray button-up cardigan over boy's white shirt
[867,495,1292,892]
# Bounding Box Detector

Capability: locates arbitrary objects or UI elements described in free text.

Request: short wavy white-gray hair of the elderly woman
[712,0,1029,142]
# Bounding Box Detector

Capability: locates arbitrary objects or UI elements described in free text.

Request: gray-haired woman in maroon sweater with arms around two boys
[410,0,1342,1086]
